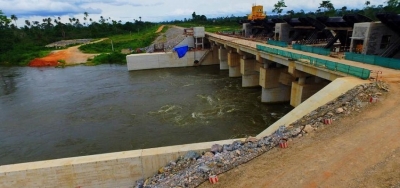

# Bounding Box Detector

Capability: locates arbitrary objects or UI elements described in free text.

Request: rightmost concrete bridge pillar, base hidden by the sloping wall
[290,79,327,107]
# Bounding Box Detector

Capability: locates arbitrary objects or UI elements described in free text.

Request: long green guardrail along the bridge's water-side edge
[256,44,371,80]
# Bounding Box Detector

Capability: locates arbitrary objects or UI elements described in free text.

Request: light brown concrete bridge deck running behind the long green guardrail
[206,32,400,82]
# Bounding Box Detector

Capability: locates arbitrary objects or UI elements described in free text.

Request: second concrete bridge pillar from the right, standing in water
[260,68,291,102]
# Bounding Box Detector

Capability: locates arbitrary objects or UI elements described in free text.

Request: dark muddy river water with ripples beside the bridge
[0,65,292,165]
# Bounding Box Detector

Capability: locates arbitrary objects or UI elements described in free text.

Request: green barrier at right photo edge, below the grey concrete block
[344,52,400,70]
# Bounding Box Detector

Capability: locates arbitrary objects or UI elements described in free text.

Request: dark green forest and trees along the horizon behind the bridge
[0,0,400,66]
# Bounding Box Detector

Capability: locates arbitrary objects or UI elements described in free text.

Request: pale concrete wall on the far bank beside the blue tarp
[126,50,219,70]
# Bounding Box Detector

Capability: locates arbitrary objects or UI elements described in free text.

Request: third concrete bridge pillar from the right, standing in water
[240,56,261,87]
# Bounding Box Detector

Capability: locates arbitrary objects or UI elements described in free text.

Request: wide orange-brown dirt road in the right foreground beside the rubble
[200,83,400,188]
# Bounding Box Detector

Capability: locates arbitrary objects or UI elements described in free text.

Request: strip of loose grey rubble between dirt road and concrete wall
[136,82,389,188]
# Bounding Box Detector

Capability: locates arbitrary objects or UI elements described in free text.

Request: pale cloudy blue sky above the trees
[0,0,386,27]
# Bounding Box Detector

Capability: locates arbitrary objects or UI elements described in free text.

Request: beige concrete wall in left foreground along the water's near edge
[0,139,243,188]
